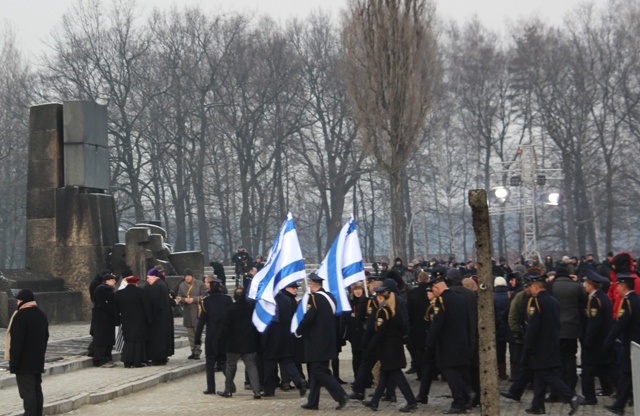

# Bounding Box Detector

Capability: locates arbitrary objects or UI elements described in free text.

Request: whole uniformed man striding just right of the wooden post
[524,276,583,415]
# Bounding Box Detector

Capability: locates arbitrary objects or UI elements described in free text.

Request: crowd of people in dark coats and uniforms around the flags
[76,249,640,414]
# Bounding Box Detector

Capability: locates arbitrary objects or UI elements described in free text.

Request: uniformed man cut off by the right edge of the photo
[604,274,640,415]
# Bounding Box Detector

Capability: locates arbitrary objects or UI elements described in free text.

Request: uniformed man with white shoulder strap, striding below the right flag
[295,273,347,410]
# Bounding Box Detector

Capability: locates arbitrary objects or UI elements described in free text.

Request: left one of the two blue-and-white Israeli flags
[249,213,306,332]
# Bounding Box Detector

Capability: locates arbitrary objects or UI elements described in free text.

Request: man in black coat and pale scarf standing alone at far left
[4,289,49,416]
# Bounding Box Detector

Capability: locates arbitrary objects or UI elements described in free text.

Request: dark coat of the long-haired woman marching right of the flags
[366,306,407,371]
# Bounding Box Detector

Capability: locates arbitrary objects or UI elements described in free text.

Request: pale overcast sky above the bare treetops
[0,0,605,56]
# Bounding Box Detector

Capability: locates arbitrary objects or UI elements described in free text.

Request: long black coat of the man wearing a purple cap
[144,279,174,360]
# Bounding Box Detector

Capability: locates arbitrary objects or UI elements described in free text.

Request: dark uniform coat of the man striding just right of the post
[524,290,560,370]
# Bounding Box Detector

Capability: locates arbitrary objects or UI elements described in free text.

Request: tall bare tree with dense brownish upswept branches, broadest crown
[344,0,441,258]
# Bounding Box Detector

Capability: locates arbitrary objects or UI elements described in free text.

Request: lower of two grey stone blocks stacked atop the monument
[64,143,109,190]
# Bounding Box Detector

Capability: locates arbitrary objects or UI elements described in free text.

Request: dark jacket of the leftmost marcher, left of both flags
[195,292,235,356]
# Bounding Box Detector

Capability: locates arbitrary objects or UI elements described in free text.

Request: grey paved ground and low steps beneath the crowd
[0,319,633,416]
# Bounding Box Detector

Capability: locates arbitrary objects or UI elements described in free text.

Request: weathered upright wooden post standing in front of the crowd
[469,189,500,416]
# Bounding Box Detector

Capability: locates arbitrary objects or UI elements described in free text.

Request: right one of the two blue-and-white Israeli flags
[317,215,365,314]
